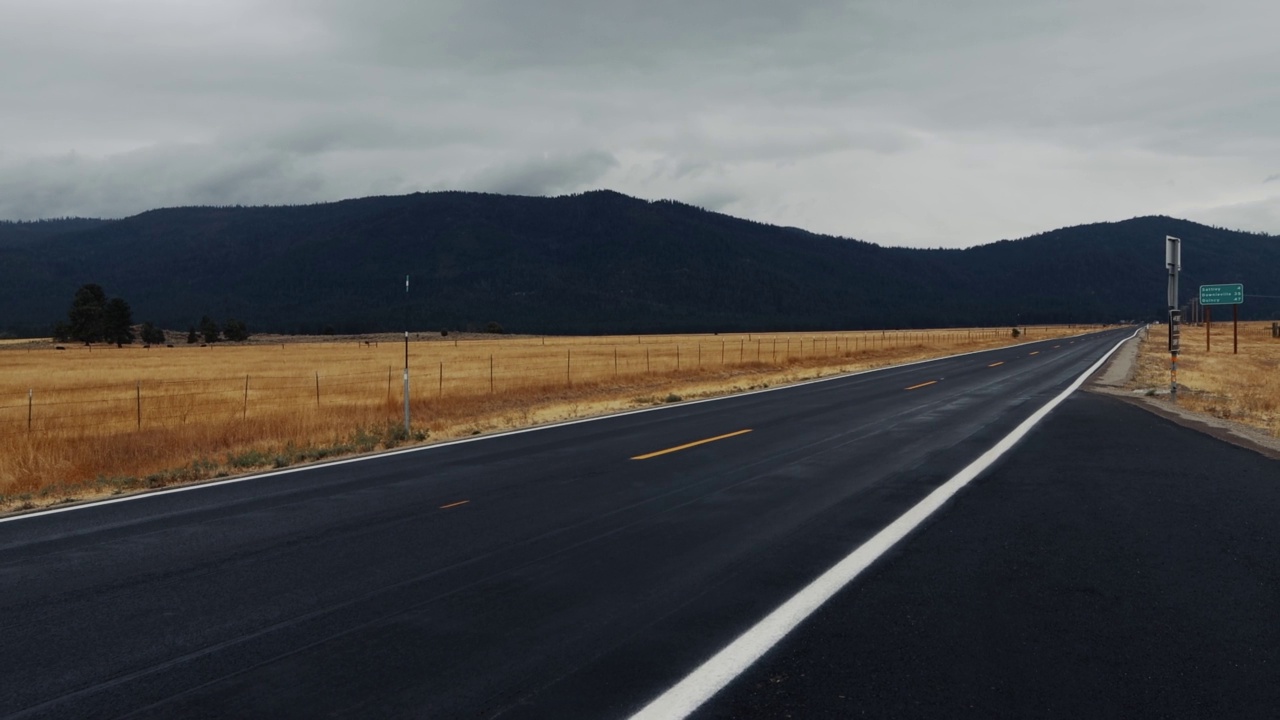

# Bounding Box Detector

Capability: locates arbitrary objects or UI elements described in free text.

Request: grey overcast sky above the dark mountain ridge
[0,0,1280,247]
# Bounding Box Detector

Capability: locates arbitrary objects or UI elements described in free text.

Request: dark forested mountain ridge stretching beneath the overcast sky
[0,191,1280,334]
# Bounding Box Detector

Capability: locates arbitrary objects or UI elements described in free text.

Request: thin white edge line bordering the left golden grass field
[0,325,1121,523]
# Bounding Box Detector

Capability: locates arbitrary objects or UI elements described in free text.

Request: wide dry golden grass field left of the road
[0,327,1088,510]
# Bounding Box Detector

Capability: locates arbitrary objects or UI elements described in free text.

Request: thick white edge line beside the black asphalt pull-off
[631,331,1138,720]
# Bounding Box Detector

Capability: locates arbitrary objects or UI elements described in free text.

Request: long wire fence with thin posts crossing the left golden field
[0,329,1049,437]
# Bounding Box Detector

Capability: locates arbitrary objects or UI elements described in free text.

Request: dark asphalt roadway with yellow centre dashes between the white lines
[0,331,1172,717]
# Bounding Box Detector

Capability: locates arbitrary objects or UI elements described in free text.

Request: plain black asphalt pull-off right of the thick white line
[695,393,1280,719]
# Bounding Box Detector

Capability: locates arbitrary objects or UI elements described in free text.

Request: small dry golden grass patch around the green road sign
[1130,320,1280,436]
